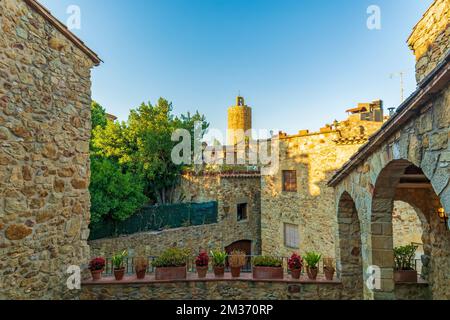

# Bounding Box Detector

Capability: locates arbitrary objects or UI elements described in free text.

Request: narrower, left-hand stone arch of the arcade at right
[337,192,364,299]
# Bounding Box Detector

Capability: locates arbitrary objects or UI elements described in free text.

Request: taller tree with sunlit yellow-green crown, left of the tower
[93,98,209,204]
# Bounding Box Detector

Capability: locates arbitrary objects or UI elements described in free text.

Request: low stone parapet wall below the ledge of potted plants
[81,275,428,300]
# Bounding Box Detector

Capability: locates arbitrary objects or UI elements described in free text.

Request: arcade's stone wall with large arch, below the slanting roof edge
[336,80,450,299]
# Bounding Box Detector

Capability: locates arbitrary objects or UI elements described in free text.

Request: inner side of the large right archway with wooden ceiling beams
[370,160,450,299]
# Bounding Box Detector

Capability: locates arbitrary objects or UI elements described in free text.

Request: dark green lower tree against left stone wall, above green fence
[89,157,147,224]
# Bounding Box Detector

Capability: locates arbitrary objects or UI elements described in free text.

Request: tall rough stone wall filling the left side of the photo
[0,0,94,299]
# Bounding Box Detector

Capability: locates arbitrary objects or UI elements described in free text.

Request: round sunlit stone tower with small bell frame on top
[227,96,252,145]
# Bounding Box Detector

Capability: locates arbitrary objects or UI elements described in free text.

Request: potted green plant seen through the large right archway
[394,244,417,283]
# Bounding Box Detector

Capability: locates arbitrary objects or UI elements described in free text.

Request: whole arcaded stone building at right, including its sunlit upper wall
[329,0,450,300]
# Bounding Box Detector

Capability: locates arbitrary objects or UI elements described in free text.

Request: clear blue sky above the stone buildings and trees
[41,0,432,133]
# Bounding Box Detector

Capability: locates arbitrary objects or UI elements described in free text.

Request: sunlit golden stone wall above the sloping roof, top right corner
[408,0,450,82]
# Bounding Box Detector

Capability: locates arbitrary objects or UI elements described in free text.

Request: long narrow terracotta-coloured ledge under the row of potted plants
[82,273,342,286]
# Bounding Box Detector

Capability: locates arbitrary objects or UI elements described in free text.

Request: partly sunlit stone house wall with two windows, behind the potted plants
[261,116,382,257]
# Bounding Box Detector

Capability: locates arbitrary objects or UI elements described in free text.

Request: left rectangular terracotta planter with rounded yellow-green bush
[152,247,189,280]
